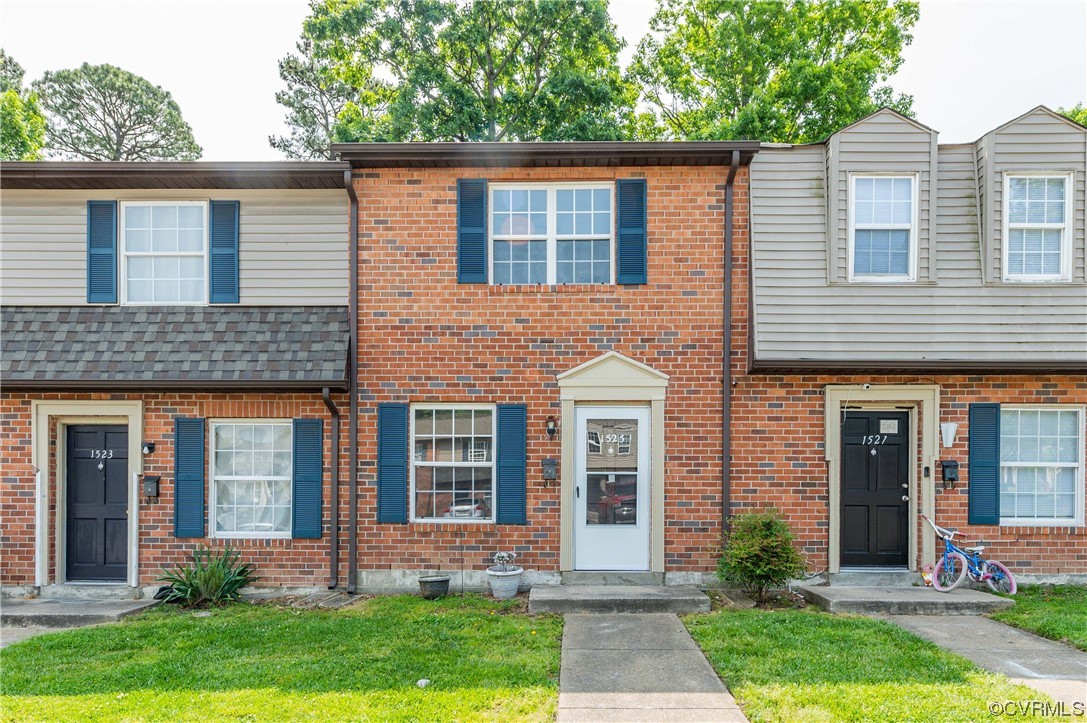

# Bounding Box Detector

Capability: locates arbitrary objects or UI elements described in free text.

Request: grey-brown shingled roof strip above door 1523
[0,307,350,388]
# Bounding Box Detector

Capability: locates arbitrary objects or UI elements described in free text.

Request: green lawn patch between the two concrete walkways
[684,610,1046,722]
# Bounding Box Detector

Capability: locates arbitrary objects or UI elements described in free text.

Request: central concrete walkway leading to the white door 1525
[559,613,747,723]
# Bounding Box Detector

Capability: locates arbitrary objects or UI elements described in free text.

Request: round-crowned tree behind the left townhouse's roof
[34,63,201,161]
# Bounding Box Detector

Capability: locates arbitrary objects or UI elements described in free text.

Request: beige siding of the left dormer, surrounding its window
[826,111,936,283]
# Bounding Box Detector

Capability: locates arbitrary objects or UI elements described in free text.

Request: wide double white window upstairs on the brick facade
[490,184,614,284]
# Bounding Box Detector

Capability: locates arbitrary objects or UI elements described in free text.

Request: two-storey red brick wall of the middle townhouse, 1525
[355,167,747,572]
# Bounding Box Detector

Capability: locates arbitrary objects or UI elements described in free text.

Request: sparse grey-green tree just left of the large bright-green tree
[268,37,363,160]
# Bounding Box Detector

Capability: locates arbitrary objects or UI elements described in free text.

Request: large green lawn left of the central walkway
[0,596,562,721]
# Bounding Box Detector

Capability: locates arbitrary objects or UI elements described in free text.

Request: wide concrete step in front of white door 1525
[528,585,710,614]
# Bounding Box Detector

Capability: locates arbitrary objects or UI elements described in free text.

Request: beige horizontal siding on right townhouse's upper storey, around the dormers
[751,146,1087,363]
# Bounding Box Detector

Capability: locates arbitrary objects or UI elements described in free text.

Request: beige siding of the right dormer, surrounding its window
[978,109,1087,283]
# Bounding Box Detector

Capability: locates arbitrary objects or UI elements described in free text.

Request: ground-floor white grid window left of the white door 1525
[411,404,495,522]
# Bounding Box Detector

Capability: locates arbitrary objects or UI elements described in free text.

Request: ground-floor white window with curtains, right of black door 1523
[210,421,293,537]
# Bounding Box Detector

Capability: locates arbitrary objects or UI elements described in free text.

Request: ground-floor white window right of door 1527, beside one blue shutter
[1000,404,1084,525]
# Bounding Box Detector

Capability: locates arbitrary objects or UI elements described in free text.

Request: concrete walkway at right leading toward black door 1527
[883,615,1087,710]
